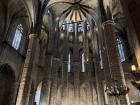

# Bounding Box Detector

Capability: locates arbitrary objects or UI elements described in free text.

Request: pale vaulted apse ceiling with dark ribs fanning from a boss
[48,0,96,23]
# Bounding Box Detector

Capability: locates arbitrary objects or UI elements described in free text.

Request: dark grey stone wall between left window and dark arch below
[0,43,25,81]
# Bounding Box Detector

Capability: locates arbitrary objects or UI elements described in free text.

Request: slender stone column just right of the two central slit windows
[82,21,94,105]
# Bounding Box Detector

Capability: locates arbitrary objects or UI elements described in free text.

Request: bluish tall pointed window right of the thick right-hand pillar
[117,37,125,62]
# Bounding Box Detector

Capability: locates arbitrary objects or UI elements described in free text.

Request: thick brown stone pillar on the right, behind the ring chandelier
[98,5,130,105]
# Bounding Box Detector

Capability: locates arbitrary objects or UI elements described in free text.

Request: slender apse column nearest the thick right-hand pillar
[92,26,105,105]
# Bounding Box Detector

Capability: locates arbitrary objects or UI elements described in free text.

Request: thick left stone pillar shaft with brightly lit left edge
[16,34,37,105]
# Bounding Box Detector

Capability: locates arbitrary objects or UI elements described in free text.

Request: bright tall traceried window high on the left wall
[12,24,23,50]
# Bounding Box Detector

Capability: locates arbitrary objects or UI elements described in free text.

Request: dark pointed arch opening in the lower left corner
[0,64,16,105]
